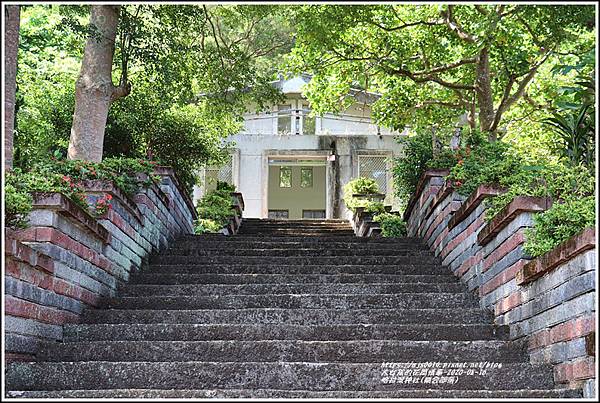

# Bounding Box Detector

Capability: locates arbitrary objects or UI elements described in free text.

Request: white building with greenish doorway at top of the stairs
[194,76,400,219]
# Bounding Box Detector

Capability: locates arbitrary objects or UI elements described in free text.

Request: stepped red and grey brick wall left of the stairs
[5,167,196,361]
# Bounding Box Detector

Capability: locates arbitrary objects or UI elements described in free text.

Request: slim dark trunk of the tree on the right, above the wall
[475,47,496,141]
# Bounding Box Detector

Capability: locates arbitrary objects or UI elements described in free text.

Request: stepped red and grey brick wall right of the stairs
[404,170,596,395]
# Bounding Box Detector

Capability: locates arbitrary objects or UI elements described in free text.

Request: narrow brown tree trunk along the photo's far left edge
[4,6,21,169]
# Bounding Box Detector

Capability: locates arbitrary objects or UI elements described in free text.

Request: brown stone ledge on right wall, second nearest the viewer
[477,196,552,246]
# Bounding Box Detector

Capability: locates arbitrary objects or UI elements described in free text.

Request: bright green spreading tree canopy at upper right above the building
[288,4,595,134]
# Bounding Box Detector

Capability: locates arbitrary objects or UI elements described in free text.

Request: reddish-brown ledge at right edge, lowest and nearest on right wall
[516,228,596,285]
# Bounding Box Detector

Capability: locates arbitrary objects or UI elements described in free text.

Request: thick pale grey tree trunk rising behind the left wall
[68,5,130,162]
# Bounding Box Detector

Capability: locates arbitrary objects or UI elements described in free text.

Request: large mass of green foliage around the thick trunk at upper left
[15,5,292,192]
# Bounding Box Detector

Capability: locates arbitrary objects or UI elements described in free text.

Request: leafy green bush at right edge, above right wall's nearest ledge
[523,196,596,257]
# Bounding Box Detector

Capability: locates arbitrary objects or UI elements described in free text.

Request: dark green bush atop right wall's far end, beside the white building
[393,130,458,201]
